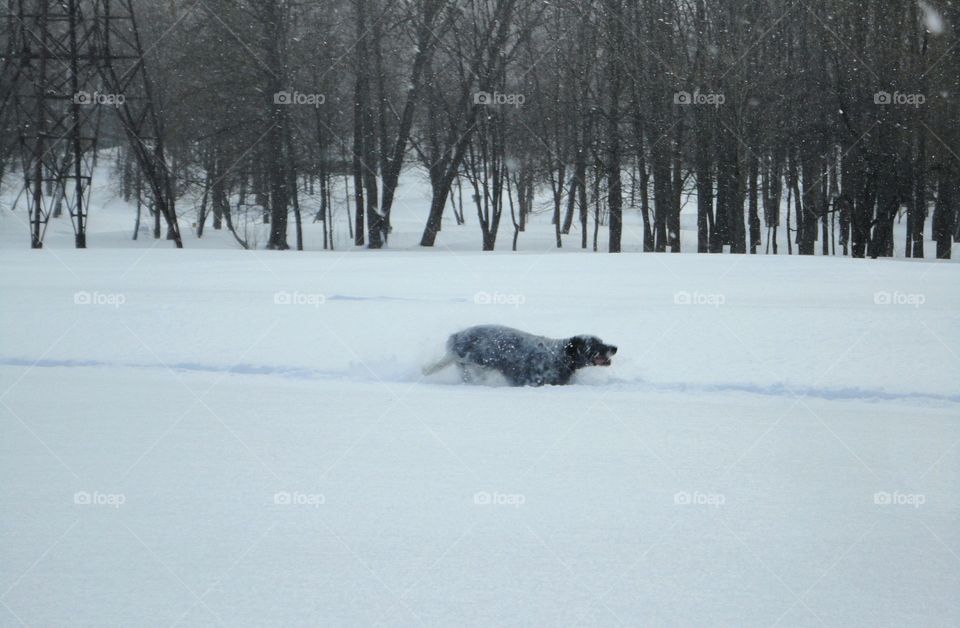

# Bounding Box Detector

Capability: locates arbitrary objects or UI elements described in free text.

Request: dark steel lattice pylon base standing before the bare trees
[2,0,182,248]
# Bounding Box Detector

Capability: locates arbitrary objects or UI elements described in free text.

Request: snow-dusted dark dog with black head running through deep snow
[423,325,617,386]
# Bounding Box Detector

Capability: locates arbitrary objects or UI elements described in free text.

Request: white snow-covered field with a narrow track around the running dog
[0,168,960,626]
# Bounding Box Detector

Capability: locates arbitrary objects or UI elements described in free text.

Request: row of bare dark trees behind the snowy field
[0,0,960,258]
